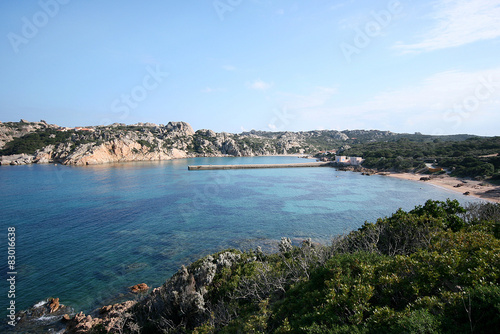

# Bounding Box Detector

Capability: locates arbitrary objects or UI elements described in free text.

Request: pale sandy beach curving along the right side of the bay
[384,173,500,203]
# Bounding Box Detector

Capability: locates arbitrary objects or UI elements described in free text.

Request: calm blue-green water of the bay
[0,157,484,311]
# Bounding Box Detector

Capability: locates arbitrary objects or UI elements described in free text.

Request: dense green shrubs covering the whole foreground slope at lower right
[102,200,500,333]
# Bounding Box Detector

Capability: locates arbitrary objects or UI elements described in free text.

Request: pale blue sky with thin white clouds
[0,0,500,135]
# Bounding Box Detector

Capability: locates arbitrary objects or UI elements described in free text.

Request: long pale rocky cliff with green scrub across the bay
[0,120,398,165]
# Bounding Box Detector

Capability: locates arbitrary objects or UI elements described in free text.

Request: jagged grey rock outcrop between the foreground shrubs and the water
[61,251,241,334]
